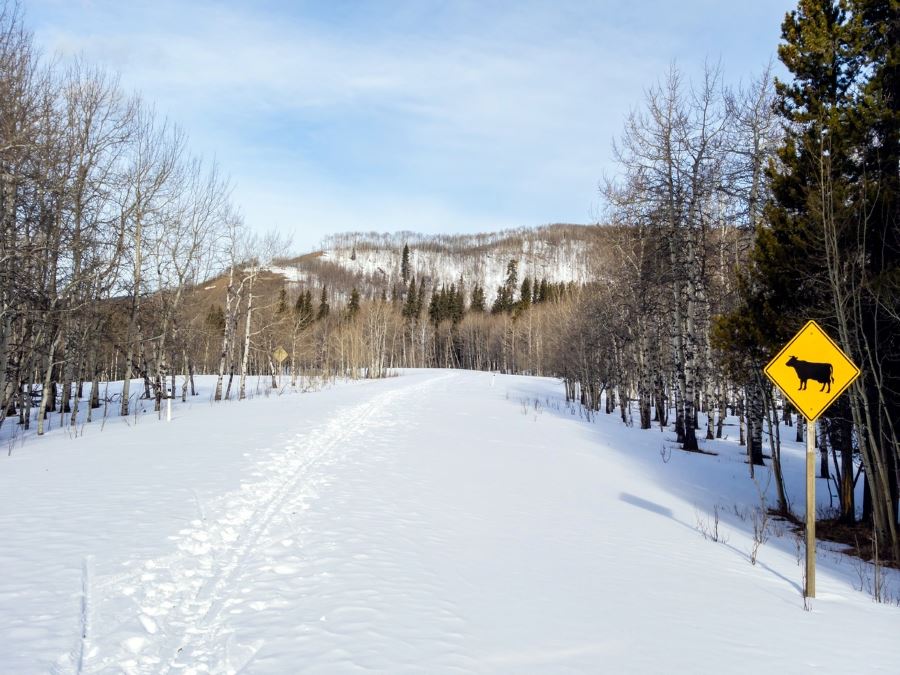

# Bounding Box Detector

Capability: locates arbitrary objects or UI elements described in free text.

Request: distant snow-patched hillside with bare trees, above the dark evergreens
[273,225,599,302]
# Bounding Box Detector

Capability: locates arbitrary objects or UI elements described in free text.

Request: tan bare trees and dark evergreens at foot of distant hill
[173,260,584,388]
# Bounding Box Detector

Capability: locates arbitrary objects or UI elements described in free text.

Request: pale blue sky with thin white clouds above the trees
[24,0,794,251]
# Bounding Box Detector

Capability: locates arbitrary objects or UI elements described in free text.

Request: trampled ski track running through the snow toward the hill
[74,374,455,673]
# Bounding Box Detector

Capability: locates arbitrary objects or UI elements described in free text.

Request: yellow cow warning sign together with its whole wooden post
[764,321,859,598]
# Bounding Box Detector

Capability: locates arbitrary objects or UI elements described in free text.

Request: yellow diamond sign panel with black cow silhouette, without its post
[765,321,859,420]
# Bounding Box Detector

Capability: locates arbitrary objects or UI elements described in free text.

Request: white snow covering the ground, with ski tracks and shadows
[0,370,900,673]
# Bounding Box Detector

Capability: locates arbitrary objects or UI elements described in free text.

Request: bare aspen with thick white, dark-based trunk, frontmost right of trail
[606,67,728,450]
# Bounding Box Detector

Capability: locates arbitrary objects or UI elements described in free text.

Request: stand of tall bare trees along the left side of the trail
[0,0,262,433]
